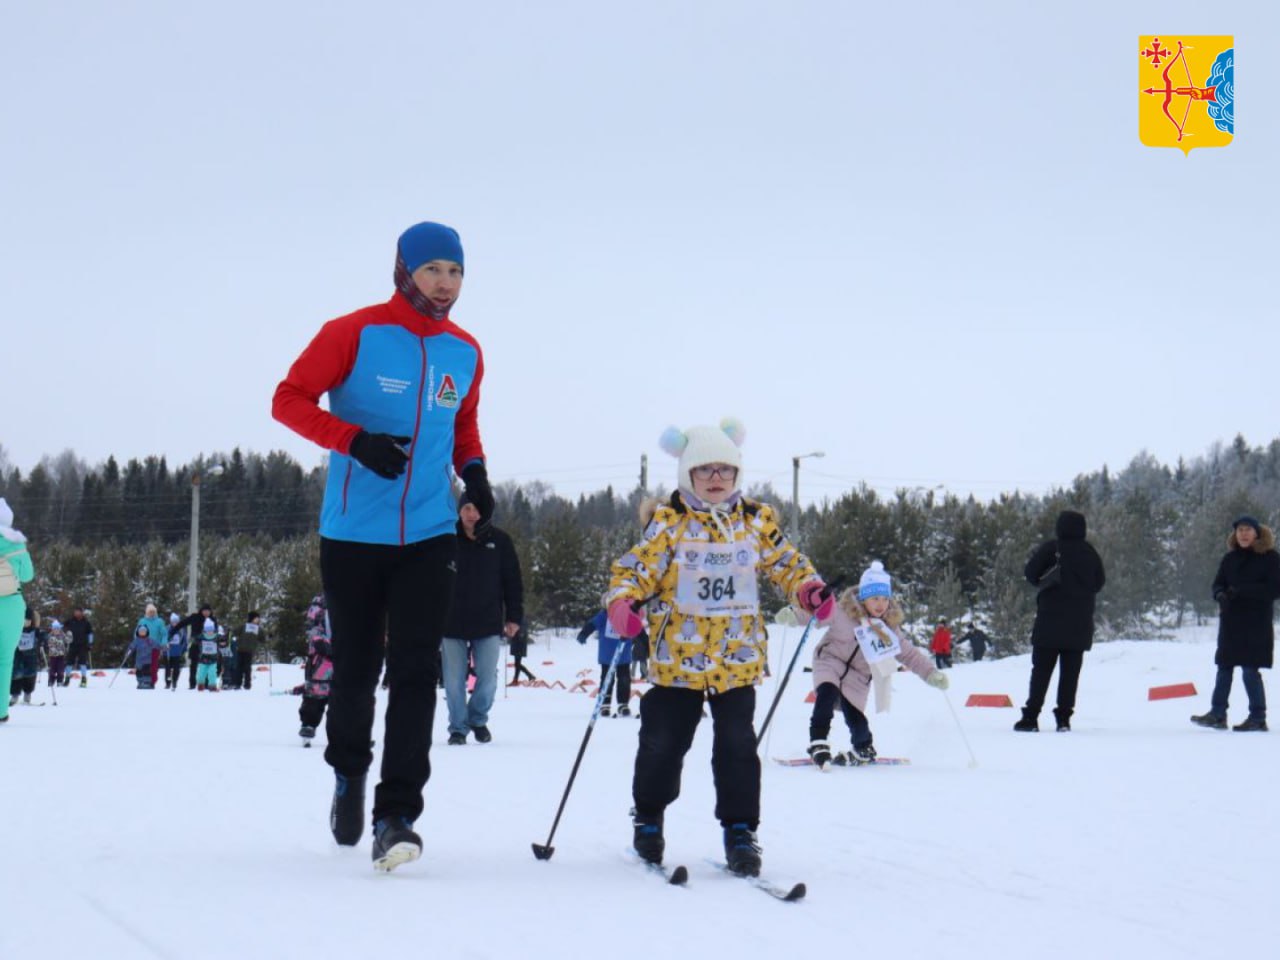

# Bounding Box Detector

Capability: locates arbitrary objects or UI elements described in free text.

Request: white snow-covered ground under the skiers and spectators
[0,627,1280,960]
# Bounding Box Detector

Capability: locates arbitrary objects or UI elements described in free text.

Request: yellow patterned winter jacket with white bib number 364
[604,492,817,695]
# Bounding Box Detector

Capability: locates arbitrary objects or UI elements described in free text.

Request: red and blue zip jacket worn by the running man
[271,293,484,544]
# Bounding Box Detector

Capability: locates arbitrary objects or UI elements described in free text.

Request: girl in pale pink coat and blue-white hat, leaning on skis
[809,561,947,771]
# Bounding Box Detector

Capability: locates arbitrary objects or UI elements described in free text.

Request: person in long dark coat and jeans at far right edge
[1192,516,1280,731]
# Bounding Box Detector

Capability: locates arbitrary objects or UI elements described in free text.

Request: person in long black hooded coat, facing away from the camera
[1014,509,1107,732]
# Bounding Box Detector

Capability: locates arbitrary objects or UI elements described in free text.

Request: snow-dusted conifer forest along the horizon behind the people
[0,436,1280,663]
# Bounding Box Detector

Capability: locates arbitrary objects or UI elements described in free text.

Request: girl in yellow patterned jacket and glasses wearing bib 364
[604,419,831,876]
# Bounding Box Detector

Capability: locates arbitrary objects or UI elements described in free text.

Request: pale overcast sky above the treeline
[0,0,1280,512]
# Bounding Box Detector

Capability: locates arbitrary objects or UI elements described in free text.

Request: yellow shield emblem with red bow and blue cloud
[1138,33,1235,154]
